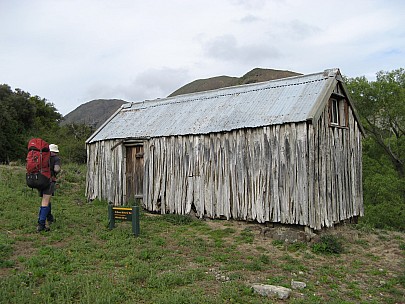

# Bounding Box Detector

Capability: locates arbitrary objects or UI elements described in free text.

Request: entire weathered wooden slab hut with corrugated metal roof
[86,69,363,229]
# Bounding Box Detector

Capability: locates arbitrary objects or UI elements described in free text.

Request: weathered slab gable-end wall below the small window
[308,104,364,229]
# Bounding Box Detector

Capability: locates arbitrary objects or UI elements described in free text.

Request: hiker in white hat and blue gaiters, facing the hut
[37,144,61,232]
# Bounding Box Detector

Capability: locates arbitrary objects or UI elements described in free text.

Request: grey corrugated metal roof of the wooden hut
[88,69,339,142]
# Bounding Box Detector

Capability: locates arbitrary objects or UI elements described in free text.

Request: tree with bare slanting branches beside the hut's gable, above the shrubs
[347,68,405,178]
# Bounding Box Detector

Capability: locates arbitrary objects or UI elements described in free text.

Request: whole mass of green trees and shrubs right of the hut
[346,68,405,231]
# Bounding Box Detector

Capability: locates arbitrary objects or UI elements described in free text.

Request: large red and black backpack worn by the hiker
[26,138,51,190]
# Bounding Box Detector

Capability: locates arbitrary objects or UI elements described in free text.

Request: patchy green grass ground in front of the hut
[0,165,405,304]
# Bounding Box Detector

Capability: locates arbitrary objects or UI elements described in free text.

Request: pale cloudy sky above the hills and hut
[0,0,405,115]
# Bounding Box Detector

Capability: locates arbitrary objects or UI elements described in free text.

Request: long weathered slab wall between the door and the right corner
[144,124,309,225]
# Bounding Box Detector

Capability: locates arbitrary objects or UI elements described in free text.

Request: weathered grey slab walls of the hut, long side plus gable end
[86,105,363,229]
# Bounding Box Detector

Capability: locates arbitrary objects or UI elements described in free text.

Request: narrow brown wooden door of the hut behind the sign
[126,144,144,202]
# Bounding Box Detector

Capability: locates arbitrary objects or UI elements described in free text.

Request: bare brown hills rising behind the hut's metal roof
[61,68,301,128]
